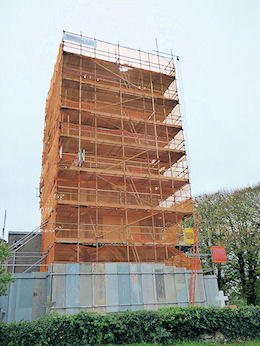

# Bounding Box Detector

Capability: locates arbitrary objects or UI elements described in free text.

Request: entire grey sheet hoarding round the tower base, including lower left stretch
[0,263,218,322]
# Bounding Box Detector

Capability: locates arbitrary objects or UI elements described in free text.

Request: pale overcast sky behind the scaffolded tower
[0,0,260,231]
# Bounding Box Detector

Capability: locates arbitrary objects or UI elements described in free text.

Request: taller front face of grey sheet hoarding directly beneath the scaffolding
[50,263,207,313]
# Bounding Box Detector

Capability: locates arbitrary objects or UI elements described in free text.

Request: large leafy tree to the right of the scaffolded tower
[190,184,260,305]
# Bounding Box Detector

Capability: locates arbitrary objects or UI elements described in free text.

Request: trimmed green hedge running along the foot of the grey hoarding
[0,307,260,346]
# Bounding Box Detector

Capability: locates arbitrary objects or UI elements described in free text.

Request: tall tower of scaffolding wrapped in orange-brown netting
[40,32,200,270]
